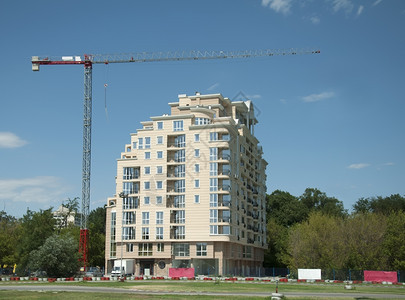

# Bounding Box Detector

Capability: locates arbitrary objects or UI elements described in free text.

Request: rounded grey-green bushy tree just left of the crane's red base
[29,234,79,277]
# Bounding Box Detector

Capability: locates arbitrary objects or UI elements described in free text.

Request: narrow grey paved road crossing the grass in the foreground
[0,284,405,299]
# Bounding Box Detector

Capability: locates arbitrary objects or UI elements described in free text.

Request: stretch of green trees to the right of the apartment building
[265,188,405,271]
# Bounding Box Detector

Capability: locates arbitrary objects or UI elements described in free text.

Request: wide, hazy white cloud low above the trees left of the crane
[0,176,67,206]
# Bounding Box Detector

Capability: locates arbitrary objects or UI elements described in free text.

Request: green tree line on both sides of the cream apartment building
[0,188,405,277]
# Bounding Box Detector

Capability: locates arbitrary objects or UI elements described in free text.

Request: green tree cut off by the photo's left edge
[0,211,20,268]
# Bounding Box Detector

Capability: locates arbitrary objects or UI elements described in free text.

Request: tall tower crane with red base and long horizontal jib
[31,49,320,269]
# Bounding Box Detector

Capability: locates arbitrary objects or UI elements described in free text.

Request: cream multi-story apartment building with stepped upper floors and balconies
[105,93,267,276]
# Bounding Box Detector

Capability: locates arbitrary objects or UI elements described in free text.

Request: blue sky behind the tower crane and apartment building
[0,0,405,216]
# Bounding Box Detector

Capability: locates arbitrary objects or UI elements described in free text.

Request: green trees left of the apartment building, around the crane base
[0,198,105,277]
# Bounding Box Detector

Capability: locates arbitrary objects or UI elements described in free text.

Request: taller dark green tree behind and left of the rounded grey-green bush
[16,208,55,273]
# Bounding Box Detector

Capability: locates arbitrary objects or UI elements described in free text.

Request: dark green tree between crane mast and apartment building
[88,207,106,267]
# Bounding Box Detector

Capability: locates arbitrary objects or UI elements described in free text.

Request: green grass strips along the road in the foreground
[0,281,405,300]
